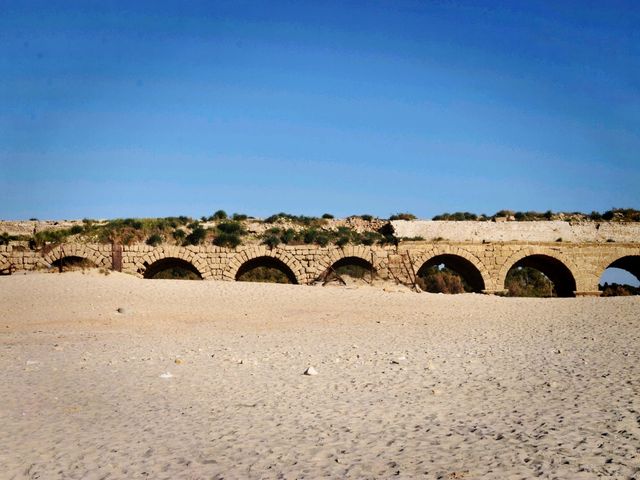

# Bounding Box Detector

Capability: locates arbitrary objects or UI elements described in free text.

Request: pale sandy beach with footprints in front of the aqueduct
[0,271,640,479]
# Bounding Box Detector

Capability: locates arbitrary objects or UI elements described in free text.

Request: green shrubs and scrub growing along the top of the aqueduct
[5,208,640,248]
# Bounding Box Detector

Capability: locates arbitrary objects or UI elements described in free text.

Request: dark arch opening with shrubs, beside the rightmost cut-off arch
[504,255,576,297]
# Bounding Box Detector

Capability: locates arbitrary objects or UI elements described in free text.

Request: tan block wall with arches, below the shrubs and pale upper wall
[0,236,640,295]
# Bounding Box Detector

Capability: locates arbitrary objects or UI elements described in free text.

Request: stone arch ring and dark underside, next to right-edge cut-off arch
[498,248,578,297]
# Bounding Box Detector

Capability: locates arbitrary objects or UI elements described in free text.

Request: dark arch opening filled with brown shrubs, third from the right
[416,254,485,293]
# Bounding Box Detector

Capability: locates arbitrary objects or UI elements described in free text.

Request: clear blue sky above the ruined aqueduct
[0,0,640,219]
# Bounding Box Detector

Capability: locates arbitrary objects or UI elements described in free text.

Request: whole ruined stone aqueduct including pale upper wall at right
[0,222,640,296]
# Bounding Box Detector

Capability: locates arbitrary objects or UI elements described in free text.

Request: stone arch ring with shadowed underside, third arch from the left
[222,245,306,283]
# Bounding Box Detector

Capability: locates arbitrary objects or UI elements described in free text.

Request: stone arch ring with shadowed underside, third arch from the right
[409,246,491,293]
